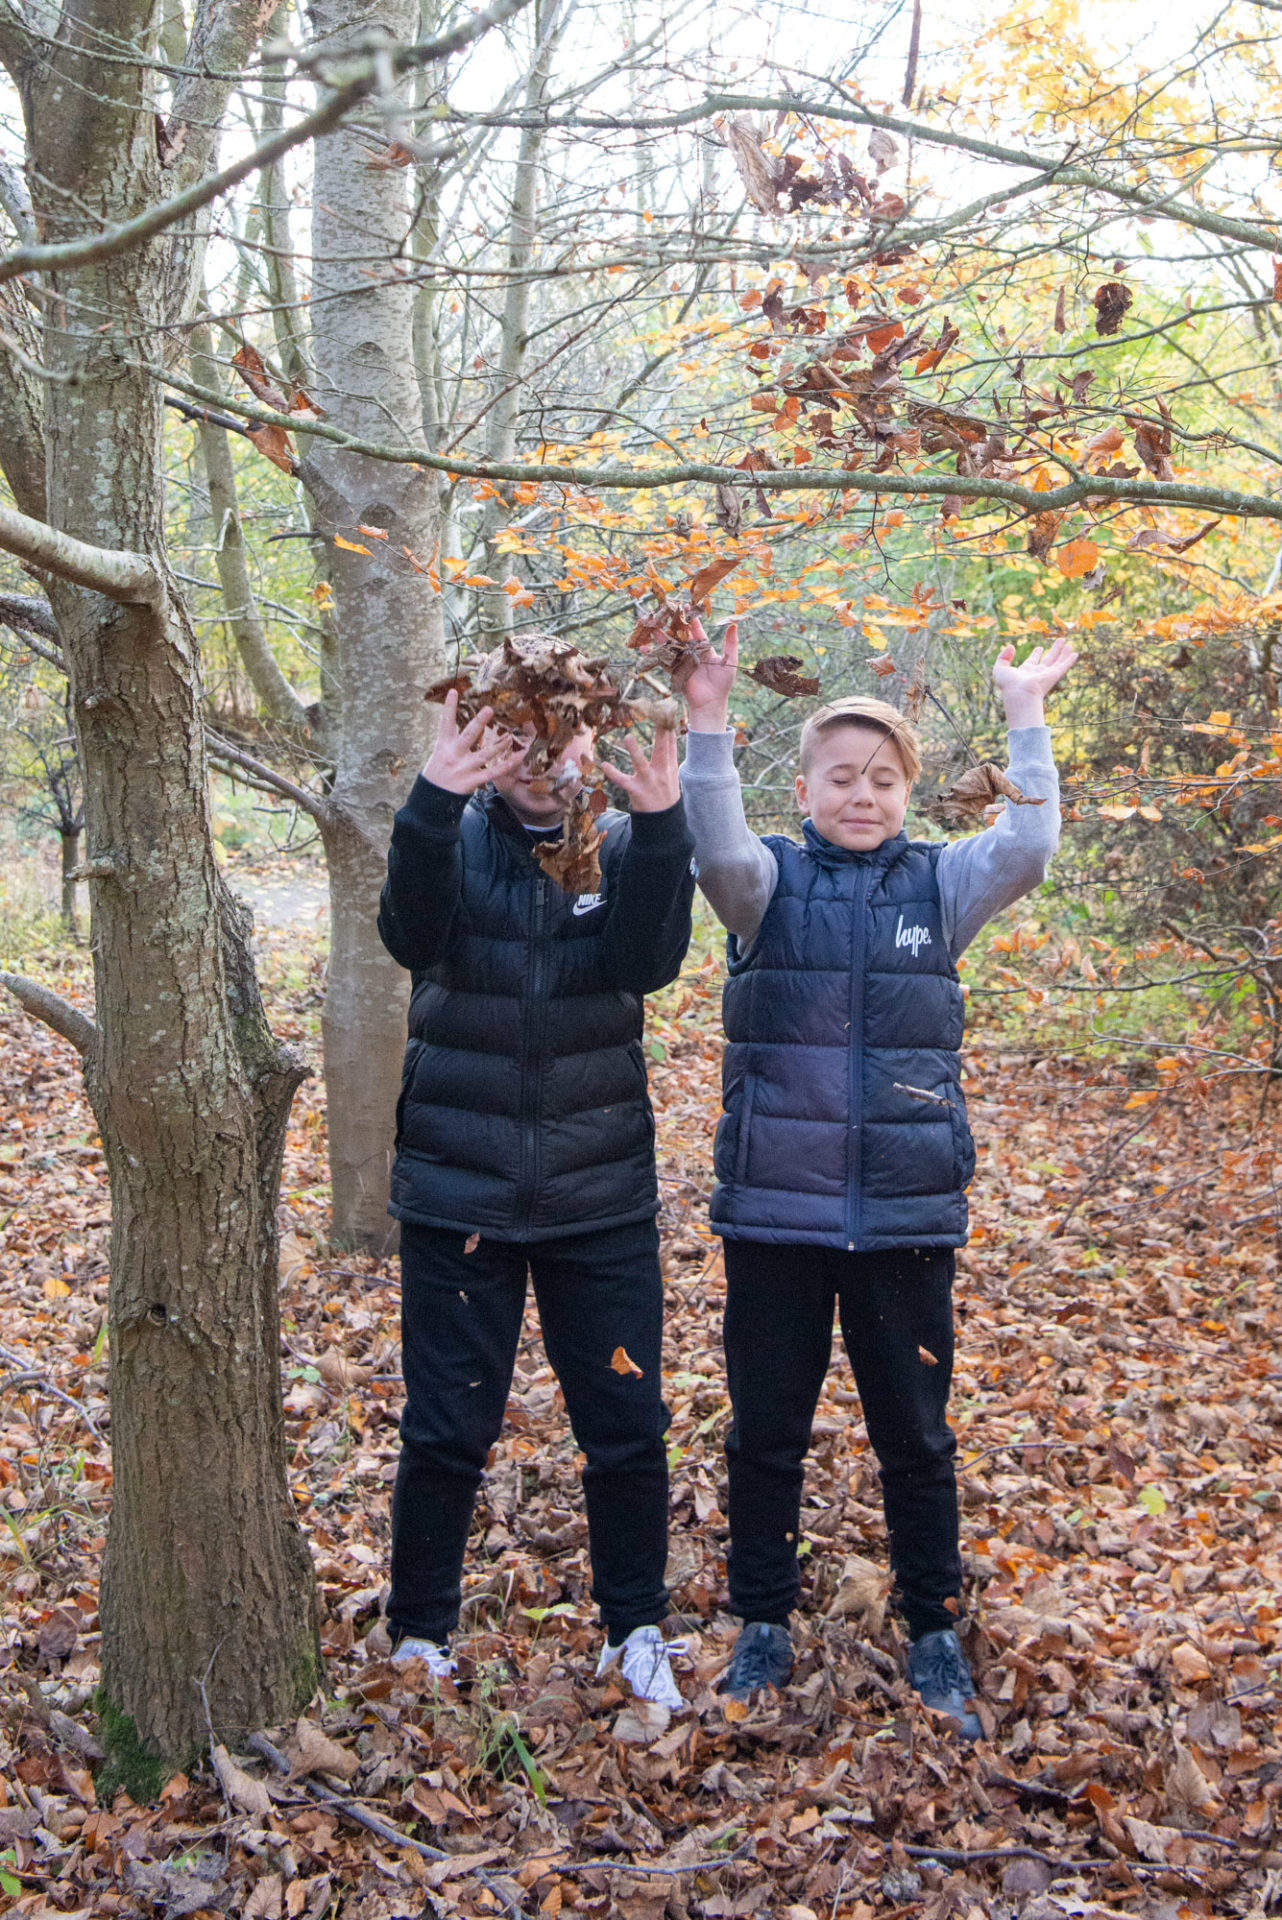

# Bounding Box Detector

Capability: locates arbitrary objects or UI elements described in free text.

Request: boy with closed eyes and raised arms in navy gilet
[681,628,1077,1740]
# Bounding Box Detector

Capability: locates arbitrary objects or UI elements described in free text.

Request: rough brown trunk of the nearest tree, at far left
[0,0,319,1778]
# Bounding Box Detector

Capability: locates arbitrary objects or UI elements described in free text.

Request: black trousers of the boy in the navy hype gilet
[725,1240,962,1640]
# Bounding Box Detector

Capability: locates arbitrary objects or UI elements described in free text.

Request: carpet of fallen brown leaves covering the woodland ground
[0,898,1282,1920]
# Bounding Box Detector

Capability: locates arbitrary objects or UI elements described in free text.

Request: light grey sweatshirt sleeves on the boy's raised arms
[681,726,1059,960]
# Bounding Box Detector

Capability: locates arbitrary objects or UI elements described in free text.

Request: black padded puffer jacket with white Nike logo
[378,778,695,1240]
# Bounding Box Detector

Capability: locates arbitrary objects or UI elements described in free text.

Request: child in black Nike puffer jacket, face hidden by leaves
[378,693,695,1709]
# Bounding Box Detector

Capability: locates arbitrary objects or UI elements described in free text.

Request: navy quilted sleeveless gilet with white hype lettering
[712,822,975,1252]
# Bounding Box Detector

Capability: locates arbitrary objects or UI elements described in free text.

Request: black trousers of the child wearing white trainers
[388,1219,668,1644]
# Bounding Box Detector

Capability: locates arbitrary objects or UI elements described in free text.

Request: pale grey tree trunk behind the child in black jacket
[303,0,443,1250]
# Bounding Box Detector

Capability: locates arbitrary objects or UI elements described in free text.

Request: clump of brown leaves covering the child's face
[426,634,677,893]
